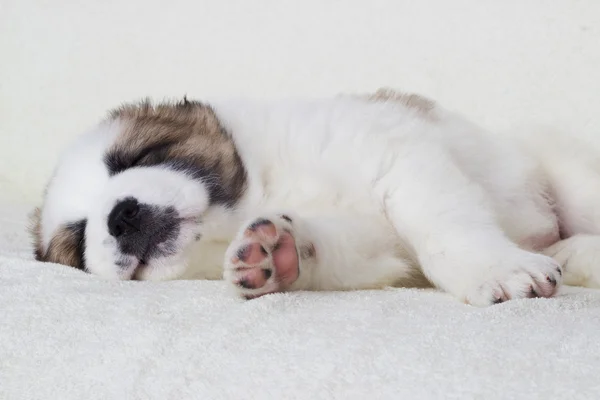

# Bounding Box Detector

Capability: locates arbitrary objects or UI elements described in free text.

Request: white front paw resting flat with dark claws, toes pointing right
[466,251,562,306]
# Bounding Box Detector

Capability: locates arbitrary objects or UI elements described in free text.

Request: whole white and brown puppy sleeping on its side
[33,90,600,306]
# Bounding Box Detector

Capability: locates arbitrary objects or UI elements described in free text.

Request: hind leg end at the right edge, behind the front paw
[543,235,600,288]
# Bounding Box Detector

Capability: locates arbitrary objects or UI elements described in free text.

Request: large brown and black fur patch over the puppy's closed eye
[105,98,246,205]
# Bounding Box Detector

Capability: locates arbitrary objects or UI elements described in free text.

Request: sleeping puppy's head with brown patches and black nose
[33,99,246,280]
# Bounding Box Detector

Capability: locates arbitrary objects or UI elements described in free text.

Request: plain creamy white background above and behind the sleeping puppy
[0,0,600,202]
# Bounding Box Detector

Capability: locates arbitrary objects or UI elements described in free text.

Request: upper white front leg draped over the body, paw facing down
[378,143,562,306]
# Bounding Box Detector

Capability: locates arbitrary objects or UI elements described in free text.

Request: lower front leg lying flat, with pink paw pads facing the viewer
[224,213,415,298]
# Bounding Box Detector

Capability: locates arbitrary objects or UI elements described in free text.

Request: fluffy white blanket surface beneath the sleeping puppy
[0,202,600,400]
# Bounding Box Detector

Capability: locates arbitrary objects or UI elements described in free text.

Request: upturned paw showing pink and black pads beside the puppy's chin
[224,215,300,299]
